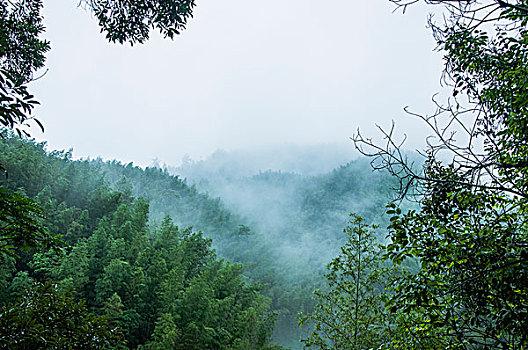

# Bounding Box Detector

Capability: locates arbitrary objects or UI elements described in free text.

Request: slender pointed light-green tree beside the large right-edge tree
[299,214,391,349]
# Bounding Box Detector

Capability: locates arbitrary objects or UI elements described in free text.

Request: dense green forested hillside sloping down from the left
[0,133,284,349]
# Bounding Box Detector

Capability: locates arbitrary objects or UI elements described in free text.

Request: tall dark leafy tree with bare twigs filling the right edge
[354,0,528,349]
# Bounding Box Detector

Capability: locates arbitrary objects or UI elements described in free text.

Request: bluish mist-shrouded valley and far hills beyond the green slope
[167,144,396,349]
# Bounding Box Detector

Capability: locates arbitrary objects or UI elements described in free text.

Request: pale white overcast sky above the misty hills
[31,0,442,165]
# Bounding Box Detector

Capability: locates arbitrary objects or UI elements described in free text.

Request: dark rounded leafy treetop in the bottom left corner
[0,283,124,350]
